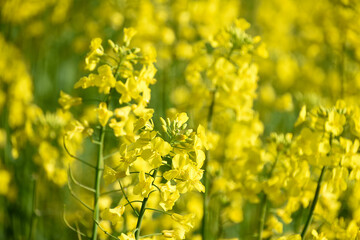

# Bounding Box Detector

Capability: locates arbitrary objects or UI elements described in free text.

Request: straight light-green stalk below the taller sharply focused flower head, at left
[91,127,105,240]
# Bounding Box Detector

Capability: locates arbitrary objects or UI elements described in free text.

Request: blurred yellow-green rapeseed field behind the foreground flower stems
[0,0,360,240]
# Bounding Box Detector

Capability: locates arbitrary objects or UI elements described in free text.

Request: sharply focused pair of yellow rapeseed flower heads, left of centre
[59,28,205,239]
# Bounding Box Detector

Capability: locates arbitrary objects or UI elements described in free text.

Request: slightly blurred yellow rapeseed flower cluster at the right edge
[262,101,360,239]
